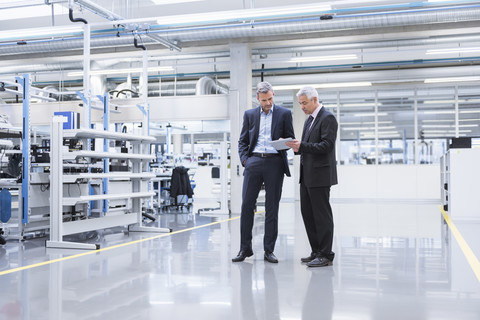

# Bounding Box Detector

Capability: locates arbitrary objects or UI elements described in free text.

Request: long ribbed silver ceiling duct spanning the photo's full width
[0,5,480,55]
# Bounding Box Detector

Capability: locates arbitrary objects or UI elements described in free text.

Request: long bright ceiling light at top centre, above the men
[157,4,332,26]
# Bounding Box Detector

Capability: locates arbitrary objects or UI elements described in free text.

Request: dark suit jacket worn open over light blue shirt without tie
[238,105,295,177]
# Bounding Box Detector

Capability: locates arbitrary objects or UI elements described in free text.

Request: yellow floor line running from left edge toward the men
[0,212,251,276]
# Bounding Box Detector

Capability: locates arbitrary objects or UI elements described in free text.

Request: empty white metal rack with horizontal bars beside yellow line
[46,116,171,249]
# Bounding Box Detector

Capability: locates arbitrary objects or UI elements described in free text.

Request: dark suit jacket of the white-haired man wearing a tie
[298,107,338,188]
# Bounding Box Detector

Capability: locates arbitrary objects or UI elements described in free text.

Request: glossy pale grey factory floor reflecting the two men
[0,202,480,320]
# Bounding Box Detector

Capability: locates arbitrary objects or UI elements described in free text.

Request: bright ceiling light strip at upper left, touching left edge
[0,25,83,41]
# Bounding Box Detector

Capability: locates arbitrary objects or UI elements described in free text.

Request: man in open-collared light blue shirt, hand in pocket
[232,82,295,263]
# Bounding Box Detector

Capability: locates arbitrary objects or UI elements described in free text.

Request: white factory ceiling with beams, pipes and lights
[0,0,480,139]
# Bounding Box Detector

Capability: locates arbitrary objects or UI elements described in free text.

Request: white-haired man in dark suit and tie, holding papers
[287,86,338,267]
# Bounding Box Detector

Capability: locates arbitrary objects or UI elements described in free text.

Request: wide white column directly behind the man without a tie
[229,43,252,214]
